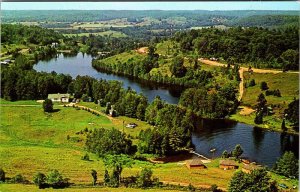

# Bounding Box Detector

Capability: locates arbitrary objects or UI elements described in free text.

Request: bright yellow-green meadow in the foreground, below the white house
[0,100,293,191]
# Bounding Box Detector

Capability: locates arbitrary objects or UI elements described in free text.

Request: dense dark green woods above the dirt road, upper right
[174,27,299,70]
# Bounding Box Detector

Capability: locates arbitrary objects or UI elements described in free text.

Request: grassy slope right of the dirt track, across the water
[231,72,299,134]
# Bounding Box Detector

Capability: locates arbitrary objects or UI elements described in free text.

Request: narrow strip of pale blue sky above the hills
[1,1,300,11]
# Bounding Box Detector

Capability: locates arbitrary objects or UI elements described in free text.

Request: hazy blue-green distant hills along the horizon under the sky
[3,10,298,27]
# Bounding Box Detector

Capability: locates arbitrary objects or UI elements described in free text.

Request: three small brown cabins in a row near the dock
[186,158,262,173]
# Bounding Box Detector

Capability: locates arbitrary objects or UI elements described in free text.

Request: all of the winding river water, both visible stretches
[34,53,299,167]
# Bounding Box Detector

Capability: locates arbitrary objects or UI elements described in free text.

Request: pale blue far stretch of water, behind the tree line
[33,53,180,104]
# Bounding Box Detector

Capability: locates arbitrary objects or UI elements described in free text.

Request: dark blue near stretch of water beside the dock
[192,119,299,167]
